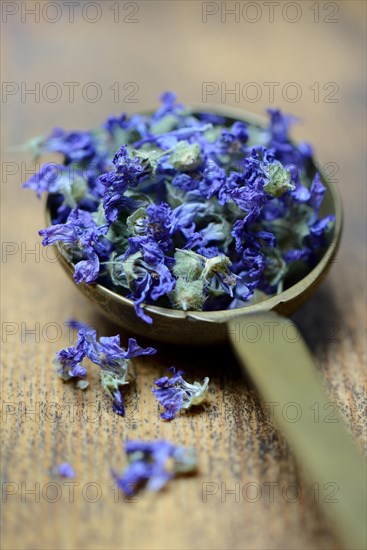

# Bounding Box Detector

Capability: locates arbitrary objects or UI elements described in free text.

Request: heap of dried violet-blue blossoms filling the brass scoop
[25,92,334,324]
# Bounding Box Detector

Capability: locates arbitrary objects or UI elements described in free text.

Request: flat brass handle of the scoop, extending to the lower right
[228,312,367,550]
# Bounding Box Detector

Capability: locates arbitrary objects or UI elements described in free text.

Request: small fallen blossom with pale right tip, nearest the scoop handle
[152,367,209,420]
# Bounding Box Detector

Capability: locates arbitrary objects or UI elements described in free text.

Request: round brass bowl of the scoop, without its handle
[46,106,342,345]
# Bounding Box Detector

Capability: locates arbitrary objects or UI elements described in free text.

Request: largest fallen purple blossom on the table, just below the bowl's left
[54,321,156,416]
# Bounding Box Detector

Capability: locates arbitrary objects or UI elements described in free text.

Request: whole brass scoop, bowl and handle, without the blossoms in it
[46,106,366,550]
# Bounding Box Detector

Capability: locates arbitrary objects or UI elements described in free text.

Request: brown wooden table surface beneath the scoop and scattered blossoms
[1,0,366,549]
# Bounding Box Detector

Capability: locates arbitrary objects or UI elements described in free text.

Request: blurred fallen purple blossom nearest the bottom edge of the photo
[112,439,197,496]
